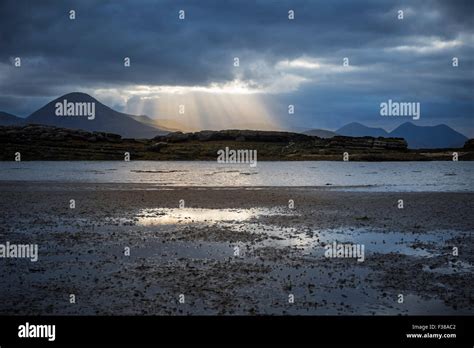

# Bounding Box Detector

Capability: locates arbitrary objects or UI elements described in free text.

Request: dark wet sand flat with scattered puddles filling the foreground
[0,182,474,315]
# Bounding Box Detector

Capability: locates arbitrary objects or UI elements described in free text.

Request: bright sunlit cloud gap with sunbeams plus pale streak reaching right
[90,56,362,131]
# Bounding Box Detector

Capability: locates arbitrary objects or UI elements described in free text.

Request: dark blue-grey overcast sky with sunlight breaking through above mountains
[0,0,474,137]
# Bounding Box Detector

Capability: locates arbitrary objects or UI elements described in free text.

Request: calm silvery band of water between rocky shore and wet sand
[0,161,474,192]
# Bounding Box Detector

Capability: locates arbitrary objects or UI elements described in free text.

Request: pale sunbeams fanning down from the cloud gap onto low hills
[92,80,281,131]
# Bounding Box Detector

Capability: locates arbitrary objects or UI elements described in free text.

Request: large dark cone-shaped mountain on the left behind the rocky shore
[25,92,167,138]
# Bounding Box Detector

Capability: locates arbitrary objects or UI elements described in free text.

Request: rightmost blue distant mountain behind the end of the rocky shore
[390,122,468,149]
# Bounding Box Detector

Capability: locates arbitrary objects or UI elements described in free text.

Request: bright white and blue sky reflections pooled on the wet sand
[133,208,472,264]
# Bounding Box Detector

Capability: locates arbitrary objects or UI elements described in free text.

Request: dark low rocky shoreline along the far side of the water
[0,124,474,161]
